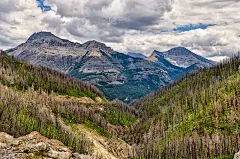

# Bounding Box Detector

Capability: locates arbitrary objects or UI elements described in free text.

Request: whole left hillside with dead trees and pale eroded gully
[0,52,135,159]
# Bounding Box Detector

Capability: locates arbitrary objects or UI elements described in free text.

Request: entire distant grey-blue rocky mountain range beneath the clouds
[8,32,215,102]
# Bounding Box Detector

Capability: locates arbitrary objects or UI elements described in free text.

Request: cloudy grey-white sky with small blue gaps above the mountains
[0,0,240,61]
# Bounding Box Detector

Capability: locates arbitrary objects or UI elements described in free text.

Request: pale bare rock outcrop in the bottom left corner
[0,132,92,159]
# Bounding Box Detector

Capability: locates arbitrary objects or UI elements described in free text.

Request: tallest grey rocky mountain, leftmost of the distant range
[9,32,86,72]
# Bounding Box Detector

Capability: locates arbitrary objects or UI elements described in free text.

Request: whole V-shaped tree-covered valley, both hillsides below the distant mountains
[0,50,240,159]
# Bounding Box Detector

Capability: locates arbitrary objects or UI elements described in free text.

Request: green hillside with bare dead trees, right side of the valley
[131,56,240,159]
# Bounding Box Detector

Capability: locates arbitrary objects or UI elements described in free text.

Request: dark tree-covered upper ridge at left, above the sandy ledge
[0,51,103,99]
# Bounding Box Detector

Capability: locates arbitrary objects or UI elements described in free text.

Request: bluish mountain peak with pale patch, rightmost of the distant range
[148,47,216,68]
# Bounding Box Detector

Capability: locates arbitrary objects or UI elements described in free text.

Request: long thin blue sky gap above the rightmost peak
[173,24,215,32]
